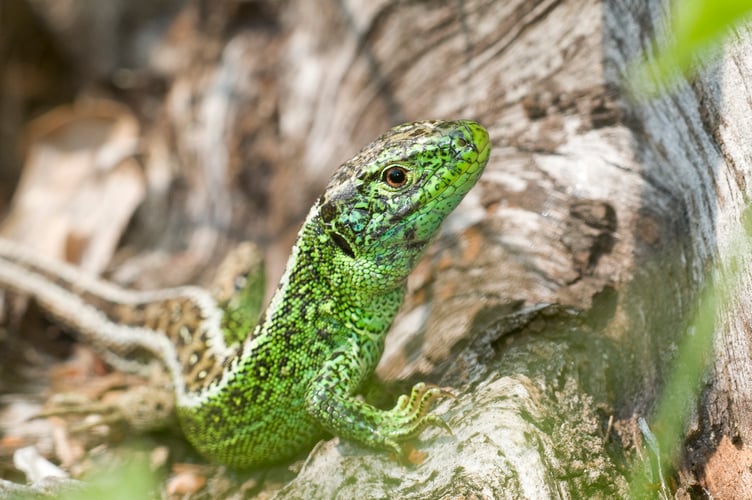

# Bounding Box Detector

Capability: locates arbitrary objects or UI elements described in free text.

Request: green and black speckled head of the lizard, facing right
[319,120,490,290]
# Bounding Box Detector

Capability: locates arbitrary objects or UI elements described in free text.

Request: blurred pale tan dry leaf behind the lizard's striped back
[0,100,145,273]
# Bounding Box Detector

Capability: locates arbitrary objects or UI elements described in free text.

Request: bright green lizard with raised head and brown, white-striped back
[0,121,490,468]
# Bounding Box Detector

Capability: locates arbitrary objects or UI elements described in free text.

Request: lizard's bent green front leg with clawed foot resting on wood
[305,338,452,456]
